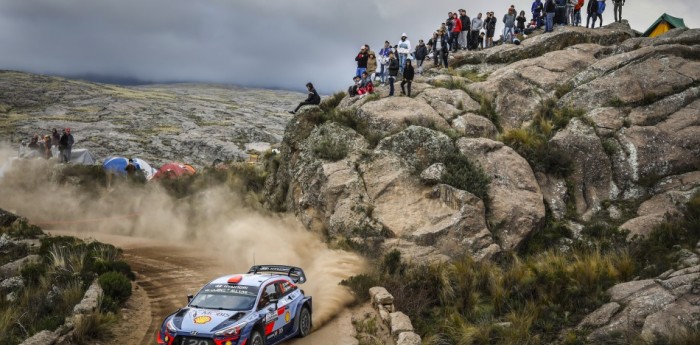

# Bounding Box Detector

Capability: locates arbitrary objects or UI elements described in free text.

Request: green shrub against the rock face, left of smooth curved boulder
[442,150,491,208]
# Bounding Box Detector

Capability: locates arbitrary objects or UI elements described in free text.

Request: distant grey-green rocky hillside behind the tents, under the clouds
[0,71,304,165]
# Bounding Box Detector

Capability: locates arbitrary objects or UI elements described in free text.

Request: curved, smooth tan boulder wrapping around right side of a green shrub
[457,138,545,250]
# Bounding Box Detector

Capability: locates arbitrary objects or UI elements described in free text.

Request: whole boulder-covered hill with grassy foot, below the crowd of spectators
[266,23,700,344]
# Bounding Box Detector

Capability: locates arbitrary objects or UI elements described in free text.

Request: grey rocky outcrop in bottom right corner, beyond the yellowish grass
[578,260,700,343]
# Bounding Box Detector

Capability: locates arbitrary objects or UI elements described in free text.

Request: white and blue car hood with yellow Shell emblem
[173,308,250,333]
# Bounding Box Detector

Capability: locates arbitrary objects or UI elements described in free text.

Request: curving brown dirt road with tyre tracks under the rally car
[50,231,357,345]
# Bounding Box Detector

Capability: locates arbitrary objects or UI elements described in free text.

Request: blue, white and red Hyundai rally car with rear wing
[156,265,312,345]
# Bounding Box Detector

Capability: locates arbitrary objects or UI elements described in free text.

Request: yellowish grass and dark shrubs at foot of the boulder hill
[341,193,700,345]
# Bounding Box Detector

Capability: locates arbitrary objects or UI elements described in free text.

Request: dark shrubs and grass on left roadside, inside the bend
[0,218,134,344]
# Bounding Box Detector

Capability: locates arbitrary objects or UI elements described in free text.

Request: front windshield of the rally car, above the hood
[190,284,258,310]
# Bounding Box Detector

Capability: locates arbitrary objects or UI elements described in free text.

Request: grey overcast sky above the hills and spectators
[0,0,700,93]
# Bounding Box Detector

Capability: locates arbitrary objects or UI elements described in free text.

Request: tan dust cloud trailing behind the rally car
[0,149,364,327]
